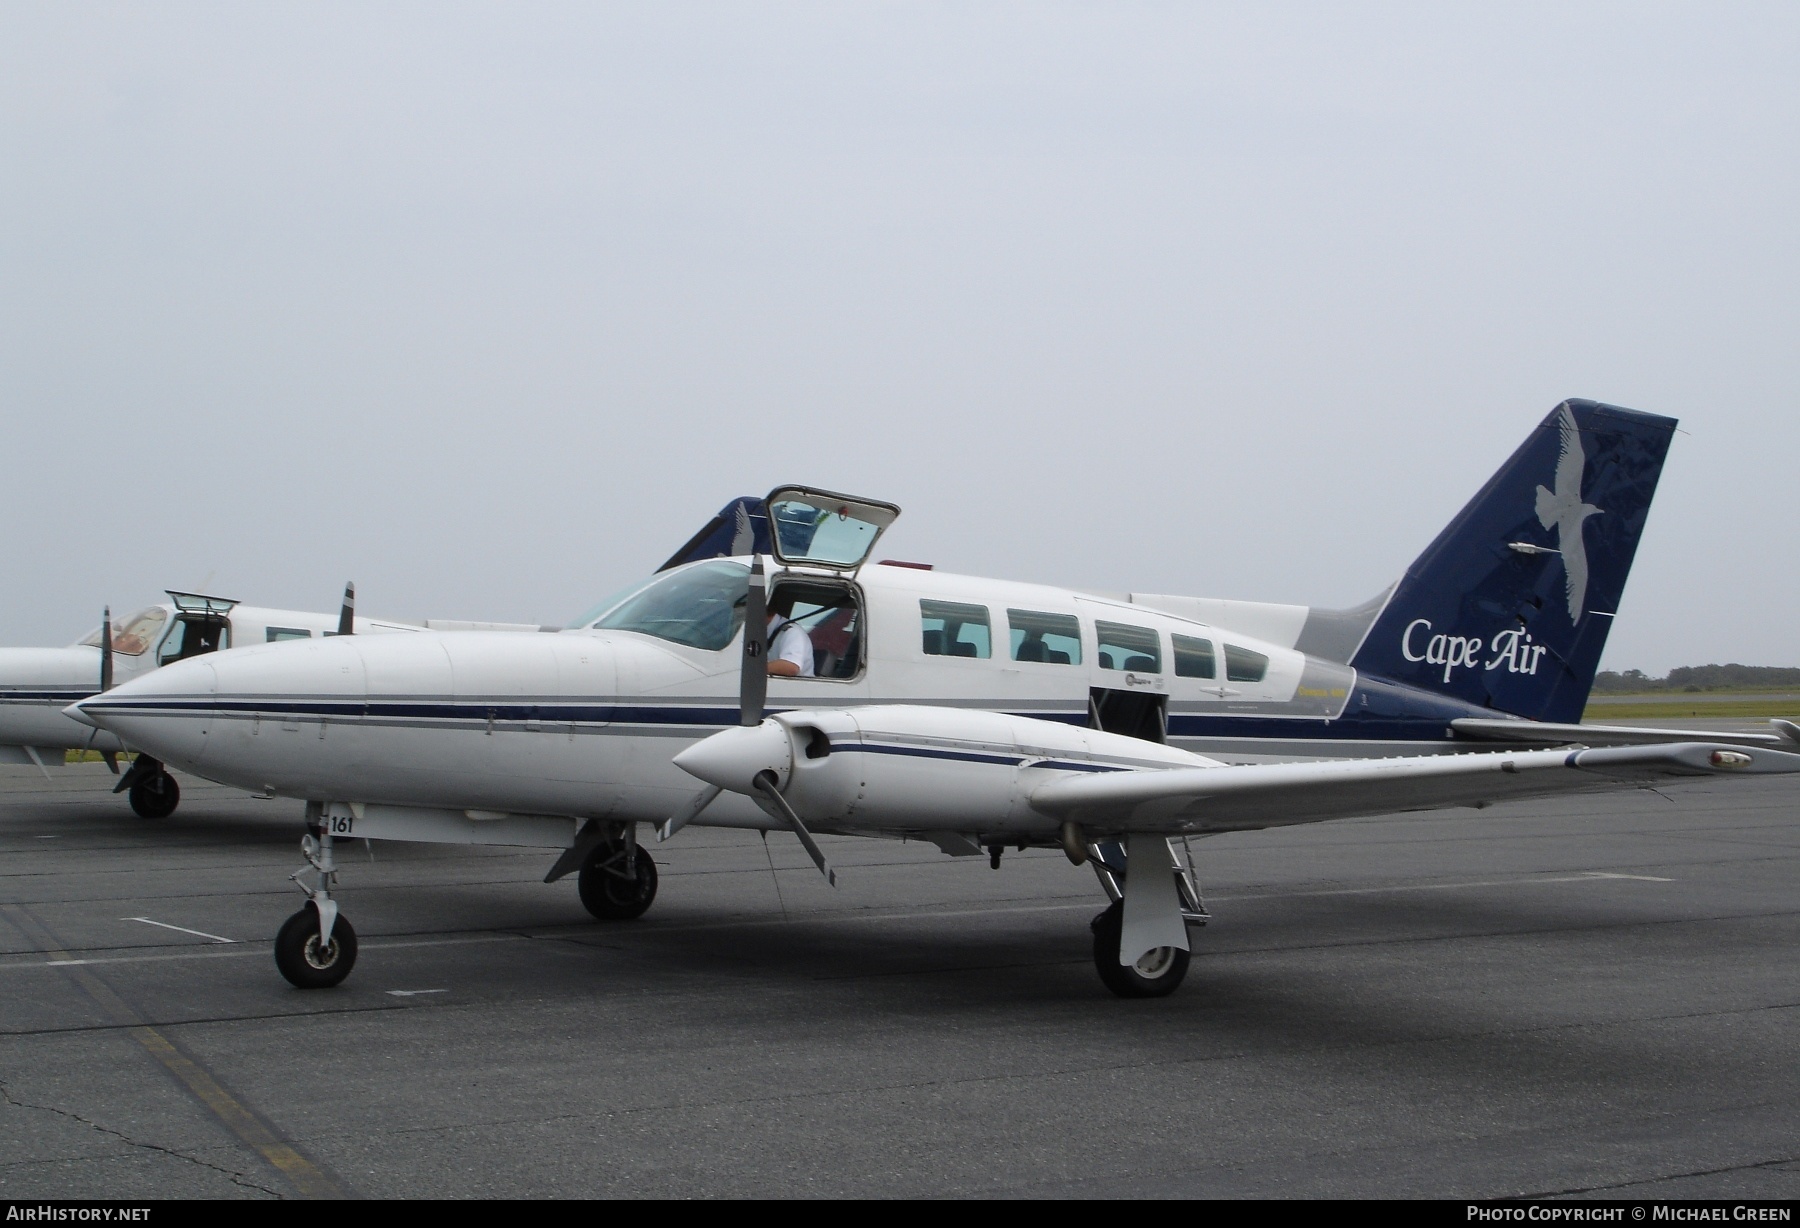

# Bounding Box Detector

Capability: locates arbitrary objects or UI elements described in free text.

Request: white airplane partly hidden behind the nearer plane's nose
[0,585,538,819]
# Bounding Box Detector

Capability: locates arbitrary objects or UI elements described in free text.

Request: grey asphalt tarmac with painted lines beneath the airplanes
[0,722,1800,1199]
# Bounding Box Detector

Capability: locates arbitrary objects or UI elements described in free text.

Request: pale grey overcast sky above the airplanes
[0,0,1800,673]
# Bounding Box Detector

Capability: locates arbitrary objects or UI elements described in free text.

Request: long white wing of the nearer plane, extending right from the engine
[1031,742,1800,835]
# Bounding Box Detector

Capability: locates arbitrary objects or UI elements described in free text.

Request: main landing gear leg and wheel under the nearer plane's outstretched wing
[1064,834,1208,998]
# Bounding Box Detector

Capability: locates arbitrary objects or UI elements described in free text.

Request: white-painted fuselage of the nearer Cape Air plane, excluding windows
[73,565,1413,843]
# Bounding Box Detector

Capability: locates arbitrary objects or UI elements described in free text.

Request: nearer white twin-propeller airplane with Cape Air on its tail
[70,402,1800,996]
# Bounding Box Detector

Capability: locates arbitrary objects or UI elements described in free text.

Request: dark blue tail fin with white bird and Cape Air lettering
[1350,400,1676,722]
